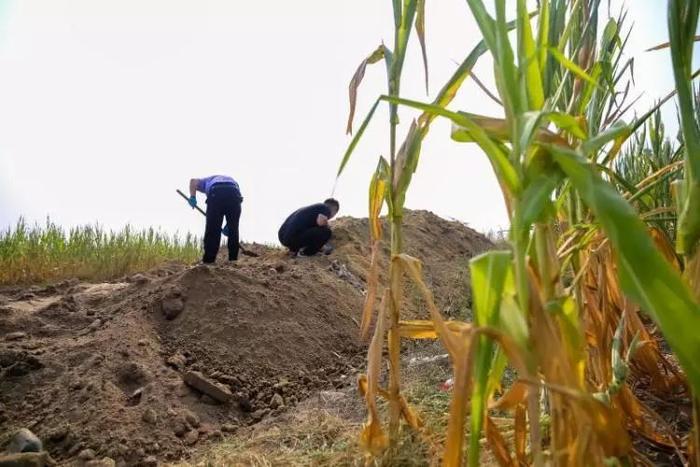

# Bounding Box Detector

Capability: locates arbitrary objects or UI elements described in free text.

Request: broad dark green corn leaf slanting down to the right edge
[544,145,700,394]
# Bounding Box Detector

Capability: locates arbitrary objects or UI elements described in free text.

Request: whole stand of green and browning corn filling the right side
[338,0,700,466]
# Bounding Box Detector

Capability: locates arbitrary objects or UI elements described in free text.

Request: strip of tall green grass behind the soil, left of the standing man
[0,218,200,285]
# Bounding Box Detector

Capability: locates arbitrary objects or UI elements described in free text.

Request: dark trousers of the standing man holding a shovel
[202,184,242,263]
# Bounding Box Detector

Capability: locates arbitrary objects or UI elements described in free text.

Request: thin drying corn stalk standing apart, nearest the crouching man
[338,1,515,455]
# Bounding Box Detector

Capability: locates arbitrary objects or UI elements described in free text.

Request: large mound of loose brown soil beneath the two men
[0,211,491,465]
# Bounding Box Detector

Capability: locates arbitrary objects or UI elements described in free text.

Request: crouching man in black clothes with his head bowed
[278,198,340,256]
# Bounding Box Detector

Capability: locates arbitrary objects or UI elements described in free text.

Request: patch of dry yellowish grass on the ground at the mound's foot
[182,343,492,467]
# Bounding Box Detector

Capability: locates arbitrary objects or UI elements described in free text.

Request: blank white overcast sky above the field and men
[0,0,692,242]
